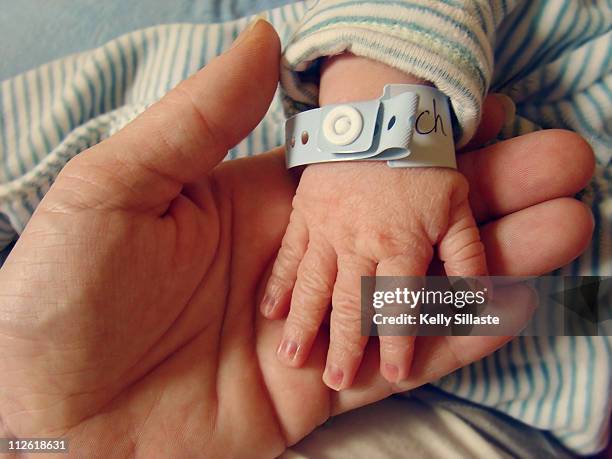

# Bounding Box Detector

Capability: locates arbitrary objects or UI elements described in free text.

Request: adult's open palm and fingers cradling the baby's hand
[0,22,592,457]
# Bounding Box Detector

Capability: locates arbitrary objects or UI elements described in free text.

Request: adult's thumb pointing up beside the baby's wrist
[58,19,280,211]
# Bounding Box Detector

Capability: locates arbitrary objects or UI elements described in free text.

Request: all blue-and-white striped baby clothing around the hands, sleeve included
[0,0,612,454]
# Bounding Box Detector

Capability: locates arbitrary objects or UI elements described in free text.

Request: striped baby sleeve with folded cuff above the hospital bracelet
[281,0,519,146]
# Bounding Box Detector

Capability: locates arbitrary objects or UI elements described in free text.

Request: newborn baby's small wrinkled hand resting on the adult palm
[261,56,487,390]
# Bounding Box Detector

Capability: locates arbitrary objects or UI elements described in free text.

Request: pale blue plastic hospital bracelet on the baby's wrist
[285,84,457,169]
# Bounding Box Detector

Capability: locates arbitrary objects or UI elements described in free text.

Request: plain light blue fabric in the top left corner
[0,0,292,80]
